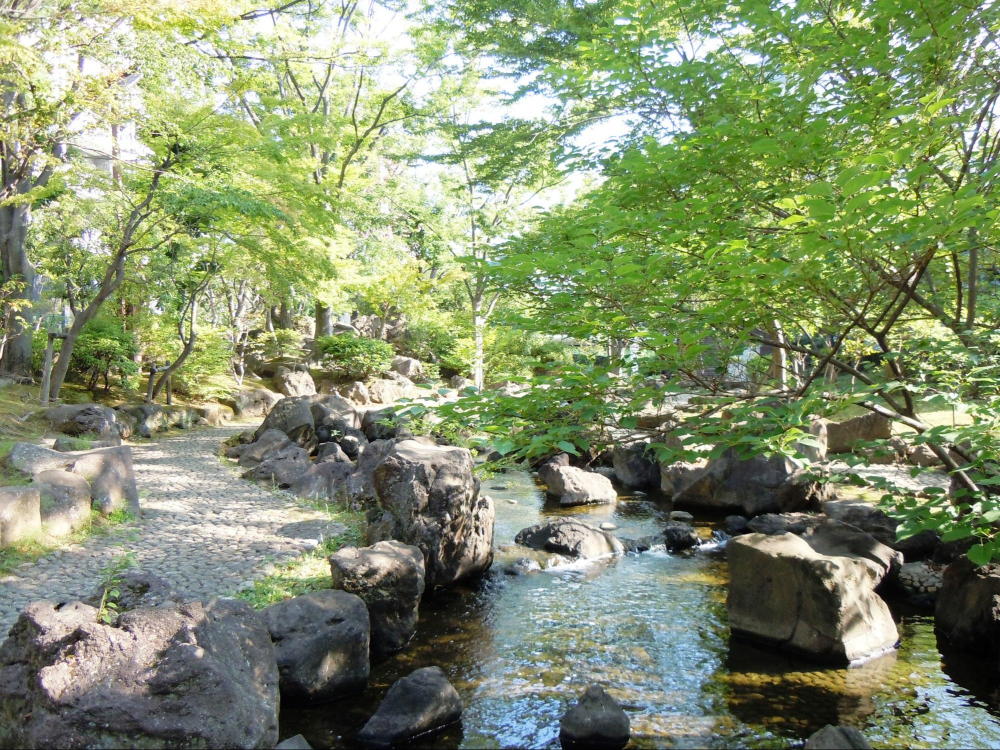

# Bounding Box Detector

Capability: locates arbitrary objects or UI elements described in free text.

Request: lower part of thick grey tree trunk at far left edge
[0,205,39,376]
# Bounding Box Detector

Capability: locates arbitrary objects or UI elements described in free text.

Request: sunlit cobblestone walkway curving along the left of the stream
[0,425,344,640]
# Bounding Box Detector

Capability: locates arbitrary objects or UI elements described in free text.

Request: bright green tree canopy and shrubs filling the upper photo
[0,0,1000,561]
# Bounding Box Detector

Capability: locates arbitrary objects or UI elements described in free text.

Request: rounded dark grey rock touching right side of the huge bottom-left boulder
[261,589,370,703]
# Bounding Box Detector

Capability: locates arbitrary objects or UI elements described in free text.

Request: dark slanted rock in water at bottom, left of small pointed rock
[358,667,462,747]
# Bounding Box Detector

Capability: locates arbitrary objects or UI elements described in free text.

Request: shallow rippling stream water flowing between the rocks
[281,472,1000,748]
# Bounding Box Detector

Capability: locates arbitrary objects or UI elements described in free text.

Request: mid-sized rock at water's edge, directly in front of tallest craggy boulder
[330,541,424,656]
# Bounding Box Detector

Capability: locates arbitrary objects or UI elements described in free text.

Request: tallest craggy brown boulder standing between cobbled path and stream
[359,440,495,588]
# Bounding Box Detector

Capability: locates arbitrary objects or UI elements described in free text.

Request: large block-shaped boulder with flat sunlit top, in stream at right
[726,521,899,664]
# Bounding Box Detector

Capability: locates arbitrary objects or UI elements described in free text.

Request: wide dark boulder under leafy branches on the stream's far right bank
[660,449,829,516]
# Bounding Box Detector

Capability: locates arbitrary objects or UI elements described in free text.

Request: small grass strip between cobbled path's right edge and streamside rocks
[236,499,365,609]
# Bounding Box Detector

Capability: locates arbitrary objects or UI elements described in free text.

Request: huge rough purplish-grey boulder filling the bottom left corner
[0,600,278,748]
